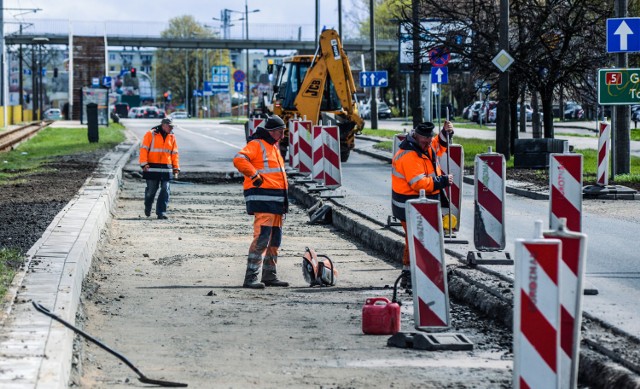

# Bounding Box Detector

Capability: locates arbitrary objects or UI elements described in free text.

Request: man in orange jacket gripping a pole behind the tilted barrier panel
[391,121,453,289]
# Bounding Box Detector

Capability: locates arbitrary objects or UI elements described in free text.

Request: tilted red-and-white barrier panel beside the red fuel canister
[405,190,451,330]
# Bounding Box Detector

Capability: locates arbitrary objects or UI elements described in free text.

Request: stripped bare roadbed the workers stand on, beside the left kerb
[72,179,512,388]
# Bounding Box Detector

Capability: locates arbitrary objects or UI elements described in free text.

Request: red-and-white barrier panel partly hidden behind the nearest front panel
[543,219,587,389]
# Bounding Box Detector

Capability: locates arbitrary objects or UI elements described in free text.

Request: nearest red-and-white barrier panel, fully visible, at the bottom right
[513,222,562,389]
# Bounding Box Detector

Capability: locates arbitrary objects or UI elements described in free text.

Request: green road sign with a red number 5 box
[598,68,640,105]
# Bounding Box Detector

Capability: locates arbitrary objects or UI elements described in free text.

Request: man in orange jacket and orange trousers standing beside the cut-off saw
[233,115,289,289]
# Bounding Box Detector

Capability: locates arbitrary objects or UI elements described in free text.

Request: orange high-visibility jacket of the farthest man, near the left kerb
[139,126,180,180]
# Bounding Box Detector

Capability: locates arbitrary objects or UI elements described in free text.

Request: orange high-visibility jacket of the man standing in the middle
[233,129,289,215]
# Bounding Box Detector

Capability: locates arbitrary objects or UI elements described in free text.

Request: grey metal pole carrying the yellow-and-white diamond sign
[496,0,511,161]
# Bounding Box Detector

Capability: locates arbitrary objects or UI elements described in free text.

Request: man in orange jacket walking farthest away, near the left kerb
[140,118,180,219]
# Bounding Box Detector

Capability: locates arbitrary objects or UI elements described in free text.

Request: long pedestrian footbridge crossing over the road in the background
[5,19,399,52]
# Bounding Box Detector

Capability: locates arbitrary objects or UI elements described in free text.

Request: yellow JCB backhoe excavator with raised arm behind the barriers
[246,29,364,162]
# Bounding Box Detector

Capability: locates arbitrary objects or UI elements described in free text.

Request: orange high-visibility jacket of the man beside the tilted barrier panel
[391,135,447,221]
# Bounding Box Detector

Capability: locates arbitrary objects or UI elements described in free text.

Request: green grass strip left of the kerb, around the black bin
[0,123,125,185]
